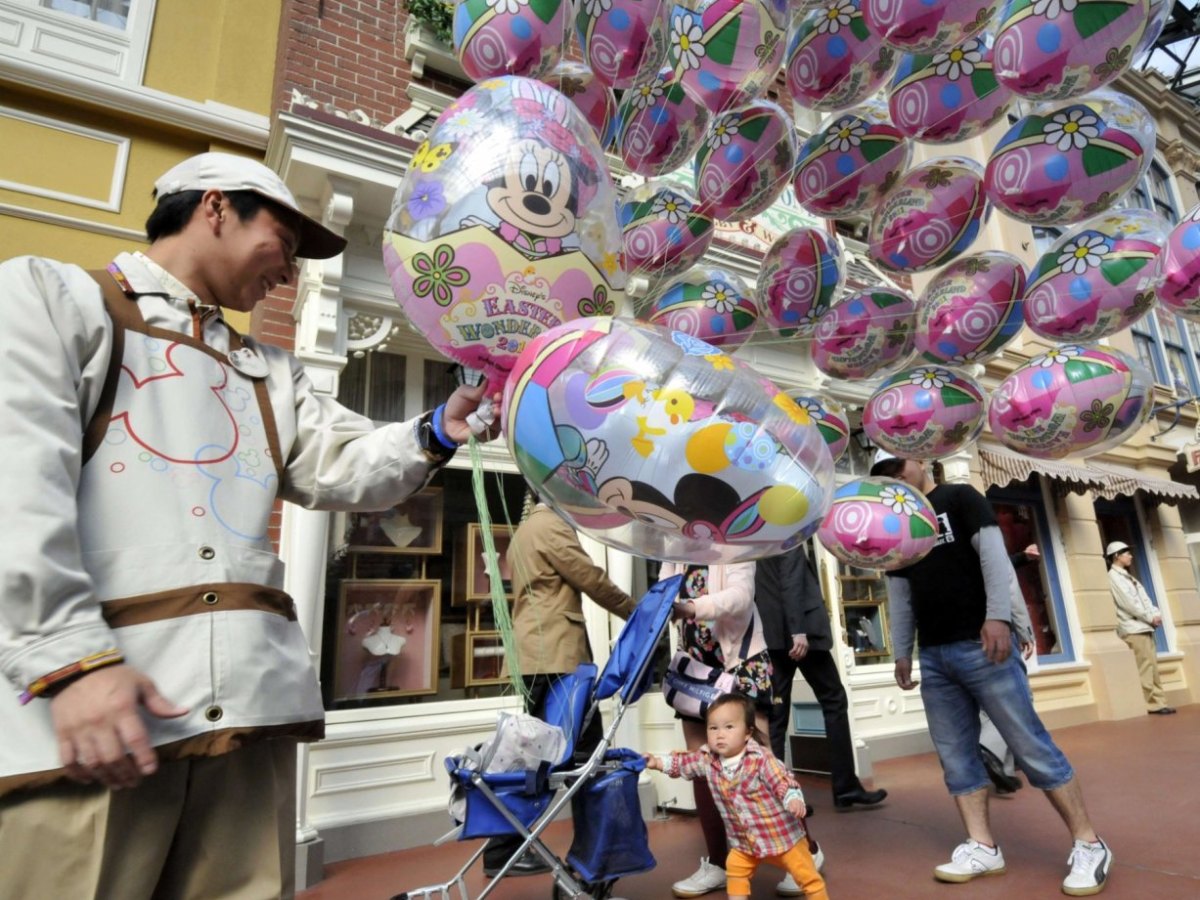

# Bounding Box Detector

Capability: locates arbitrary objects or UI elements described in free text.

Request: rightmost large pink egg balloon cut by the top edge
[996,0,1150,100]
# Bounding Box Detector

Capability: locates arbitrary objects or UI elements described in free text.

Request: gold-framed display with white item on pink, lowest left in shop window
[334,580,442,702]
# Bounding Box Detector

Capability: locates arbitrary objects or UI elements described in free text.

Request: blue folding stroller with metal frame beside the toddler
[392,576,682,900]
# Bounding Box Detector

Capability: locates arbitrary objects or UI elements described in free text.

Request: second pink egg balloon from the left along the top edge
[575,0,667,90]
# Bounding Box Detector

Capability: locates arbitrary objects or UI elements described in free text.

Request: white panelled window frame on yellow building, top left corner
[0,0,157,86]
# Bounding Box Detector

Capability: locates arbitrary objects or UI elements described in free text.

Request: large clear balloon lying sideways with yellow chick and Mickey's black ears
[502,317,833,563]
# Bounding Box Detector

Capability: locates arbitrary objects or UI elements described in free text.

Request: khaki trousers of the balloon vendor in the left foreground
[0,739,296,900]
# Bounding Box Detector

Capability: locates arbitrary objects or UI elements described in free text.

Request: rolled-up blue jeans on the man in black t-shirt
[920,640,1075,796]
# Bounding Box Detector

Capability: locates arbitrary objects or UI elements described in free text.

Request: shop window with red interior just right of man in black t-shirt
[988,488,1074,662]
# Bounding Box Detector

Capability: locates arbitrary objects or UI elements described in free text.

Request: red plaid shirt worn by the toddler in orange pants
[665,738,804,859]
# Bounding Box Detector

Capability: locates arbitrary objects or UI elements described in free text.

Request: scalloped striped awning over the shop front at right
[979,448,1200,505]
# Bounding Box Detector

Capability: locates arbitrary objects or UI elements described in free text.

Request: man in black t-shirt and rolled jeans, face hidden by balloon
[871,451,1112,896]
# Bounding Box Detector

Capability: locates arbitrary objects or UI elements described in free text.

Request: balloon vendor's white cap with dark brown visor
[154,152,346,259]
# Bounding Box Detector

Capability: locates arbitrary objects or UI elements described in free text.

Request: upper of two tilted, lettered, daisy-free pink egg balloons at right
[868,156,988,272]
